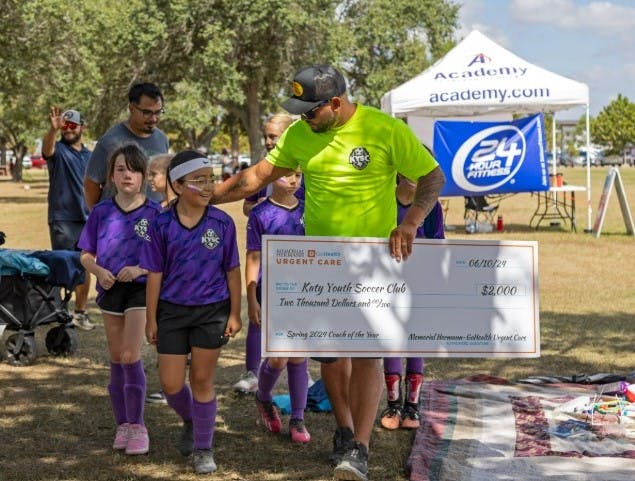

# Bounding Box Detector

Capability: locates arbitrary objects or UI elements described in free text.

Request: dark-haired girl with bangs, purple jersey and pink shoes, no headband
[78,145,161,454]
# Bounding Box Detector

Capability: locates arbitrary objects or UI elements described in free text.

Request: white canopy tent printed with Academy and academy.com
[381,30,591,230]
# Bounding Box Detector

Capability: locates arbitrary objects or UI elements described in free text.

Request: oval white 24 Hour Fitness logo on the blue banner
[452,125,527,192]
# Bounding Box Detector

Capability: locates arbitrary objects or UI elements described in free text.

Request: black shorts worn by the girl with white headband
[157,299,231,354]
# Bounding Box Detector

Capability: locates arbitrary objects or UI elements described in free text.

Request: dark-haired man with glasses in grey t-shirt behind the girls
[84,83,169,210]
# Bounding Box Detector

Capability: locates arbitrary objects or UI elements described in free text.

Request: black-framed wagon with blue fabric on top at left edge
[0,249,84,366]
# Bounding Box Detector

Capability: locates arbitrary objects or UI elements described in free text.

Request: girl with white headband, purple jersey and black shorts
[140,151,241,473]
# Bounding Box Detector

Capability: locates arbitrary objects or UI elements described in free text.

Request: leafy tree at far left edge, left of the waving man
[0,0,98,180]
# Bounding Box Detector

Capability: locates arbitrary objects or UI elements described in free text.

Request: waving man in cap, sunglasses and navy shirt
[42,107,95,331]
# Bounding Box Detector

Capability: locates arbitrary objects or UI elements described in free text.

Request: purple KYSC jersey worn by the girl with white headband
[140,205,240,306]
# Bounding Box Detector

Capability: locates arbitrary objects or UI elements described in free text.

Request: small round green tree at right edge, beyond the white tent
[591,94,635,154]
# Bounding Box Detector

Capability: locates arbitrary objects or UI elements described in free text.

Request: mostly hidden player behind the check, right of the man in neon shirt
[380,175,445,430]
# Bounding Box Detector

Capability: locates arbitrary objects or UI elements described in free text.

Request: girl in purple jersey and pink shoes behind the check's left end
[245,171,311,443]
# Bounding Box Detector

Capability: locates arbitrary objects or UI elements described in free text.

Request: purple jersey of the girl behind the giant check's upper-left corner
[247,198,304,291]
